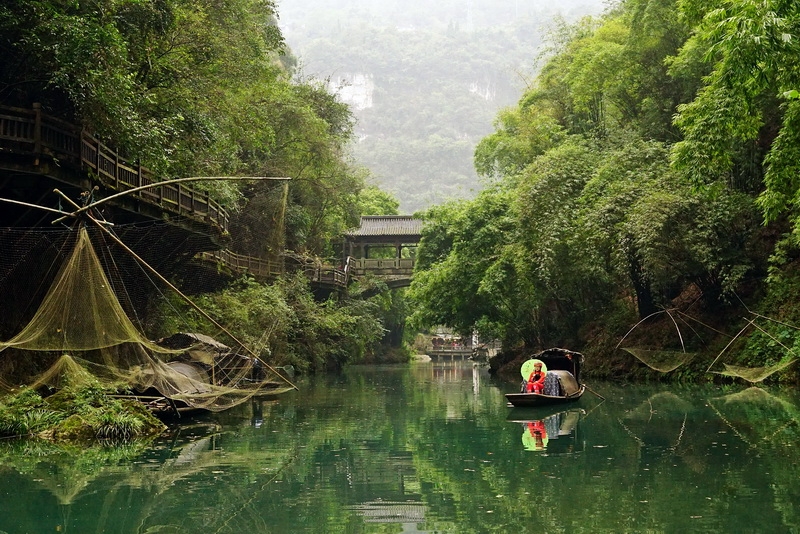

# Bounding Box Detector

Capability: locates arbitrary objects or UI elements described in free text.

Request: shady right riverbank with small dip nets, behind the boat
[490,284,800,385]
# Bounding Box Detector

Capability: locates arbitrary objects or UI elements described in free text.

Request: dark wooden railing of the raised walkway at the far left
[0,104,228,231]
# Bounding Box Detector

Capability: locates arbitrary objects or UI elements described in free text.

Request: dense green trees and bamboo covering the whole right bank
[412,0,800,381]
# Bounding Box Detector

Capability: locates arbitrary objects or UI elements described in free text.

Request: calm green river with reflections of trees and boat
[0,361,800,534]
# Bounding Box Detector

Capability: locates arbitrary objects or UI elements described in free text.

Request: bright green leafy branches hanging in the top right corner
[674,1,800,209]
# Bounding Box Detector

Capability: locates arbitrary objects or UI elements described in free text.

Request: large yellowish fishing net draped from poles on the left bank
[0,227,290,411]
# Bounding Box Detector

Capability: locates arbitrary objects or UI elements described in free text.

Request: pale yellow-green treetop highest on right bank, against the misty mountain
[523,0,697,140]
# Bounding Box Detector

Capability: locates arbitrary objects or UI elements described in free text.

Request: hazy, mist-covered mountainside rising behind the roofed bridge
[279,0,602,212]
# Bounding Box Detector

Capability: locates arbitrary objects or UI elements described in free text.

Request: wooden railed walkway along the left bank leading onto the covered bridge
[0,104,419,289]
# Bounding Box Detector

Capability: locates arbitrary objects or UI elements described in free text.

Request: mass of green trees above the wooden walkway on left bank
[0,0,384,257]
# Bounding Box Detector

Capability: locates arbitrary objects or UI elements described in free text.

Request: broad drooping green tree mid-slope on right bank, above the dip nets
[581,139,757,318]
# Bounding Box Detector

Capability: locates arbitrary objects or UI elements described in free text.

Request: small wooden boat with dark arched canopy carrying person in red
[506,348,586,408]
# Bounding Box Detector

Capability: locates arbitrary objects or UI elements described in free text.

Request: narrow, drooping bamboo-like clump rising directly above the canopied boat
[513,138,607,341]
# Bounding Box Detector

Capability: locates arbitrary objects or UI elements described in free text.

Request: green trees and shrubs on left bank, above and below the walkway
[0,0,406,370]
